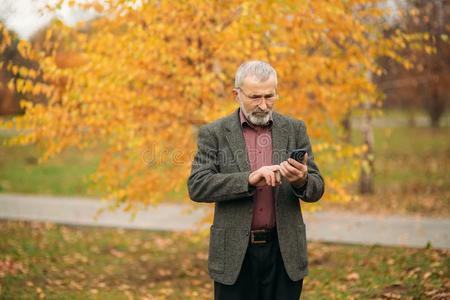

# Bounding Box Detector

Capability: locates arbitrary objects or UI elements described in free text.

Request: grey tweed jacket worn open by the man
[187,109,324,285]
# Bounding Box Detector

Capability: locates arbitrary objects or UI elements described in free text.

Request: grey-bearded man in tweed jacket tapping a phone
[188,61,324,300]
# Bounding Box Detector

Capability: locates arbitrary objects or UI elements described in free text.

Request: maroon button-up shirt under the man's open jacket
[239,109,275,229]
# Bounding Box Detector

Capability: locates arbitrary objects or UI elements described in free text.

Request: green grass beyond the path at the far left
[0,137,100,195]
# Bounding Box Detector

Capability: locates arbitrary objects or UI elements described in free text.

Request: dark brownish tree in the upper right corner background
[377,0,450,127]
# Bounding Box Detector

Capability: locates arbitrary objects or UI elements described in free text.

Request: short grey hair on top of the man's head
[234,60,277,88]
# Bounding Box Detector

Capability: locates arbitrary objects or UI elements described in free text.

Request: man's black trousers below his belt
[214,231,303,300]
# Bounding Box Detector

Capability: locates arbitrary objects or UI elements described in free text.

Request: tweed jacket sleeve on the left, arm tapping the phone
[188,126,256,202]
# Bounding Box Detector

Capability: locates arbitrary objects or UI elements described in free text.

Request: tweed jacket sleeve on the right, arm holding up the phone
[291,121,325,202]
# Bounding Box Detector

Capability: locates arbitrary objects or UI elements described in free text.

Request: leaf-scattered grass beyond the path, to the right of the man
[323,127,450,217]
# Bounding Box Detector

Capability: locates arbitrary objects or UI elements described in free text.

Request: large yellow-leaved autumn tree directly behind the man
[0,0,422,214]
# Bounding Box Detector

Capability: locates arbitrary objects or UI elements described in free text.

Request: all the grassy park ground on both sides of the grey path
[0,109,450,300]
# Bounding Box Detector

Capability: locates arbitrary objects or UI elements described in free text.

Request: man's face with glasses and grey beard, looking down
[233,76,277,126]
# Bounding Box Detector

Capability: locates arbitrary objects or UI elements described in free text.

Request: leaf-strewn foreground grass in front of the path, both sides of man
[0,221,450,300]
